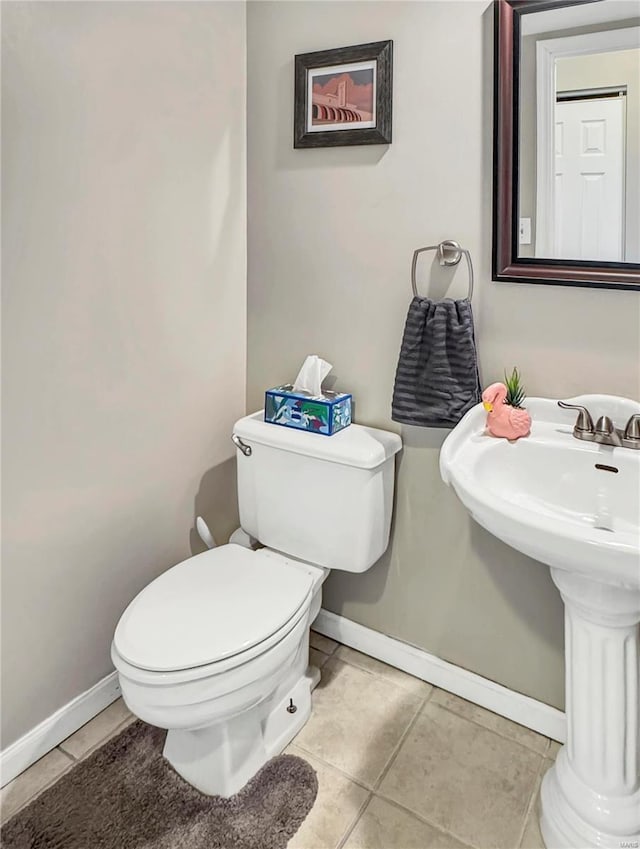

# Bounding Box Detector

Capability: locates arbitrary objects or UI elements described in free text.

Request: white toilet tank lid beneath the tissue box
[233,410,402,469]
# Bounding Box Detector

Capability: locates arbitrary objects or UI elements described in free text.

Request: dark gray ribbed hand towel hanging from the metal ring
[391,297,480,427]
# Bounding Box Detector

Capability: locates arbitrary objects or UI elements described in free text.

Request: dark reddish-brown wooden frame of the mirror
[492,0,640,291]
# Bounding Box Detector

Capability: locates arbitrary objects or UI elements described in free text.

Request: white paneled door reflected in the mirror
[553,97,625,262]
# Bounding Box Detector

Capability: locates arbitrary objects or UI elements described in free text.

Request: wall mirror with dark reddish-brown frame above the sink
[493,0,640,289]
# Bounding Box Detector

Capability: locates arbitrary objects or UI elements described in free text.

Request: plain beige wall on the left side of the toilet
[2,2,246,746]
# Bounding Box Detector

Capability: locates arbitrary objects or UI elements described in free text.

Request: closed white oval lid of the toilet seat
[113,545,313,672]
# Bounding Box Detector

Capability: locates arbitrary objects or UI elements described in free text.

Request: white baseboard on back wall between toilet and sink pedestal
[313,609,567,743]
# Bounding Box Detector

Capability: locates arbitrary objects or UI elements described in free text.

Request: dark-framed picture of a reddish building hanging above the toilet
[293,41,393,147]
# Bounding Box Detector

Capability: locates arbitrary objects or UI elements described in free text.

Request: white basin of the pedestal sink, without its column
[440,395,640,588]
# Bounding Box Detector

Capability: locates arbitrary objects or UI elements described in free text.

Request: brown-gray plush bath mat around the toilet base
[0,722,318,849]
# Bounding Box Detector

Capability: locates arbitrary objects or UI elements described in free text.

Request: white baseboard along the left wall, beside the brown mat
[0,672,120,787]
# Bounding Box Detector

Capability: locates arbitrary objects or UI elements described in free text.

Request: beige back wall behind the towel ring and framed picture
[247,2,640,706]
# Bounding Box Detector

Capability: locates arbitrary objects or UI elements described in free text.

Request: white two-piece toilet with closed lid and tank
[111,412,402,796]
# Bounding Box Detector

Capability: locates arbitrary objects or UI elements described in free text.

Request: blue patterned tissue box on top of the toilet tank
[264,383,351,436]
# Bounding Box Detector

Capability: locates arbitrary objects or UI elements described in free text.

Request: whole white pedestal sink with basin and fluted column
[440,395,640,849]
